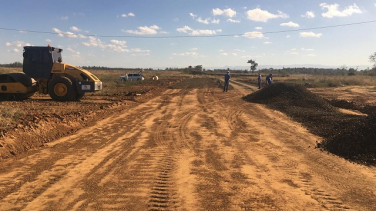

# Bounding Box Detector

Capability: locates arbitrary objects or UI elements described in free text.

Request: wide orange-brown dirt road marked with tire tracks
[0,82,376,210]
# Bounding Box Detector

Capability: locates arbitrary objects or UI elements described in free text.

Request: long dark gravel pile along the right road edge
[244,83,376,165]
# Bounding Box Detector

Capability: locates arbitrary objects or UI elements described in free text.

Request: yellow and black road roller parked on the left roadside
[0,45,102,101]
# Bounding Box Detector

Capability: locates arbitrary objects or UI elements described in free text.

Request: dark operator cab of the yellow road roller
[23,46,62,79]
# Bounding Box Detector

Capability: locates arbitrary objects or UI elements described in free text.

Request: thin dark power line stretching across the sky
[0,20,376,39]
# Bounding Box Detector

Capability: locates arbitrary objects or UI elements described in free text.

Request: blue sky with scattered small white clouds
[0,0,376,68]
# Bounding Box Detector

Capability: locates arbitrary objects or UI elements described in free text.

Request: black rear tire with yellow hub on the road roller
[48,76,77,101]
